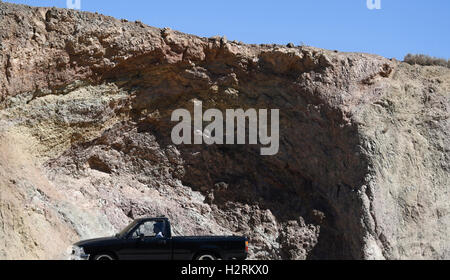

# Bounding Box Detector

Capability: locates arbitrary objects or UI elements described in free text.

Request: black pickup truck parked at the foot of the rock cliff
[71,218,248,260]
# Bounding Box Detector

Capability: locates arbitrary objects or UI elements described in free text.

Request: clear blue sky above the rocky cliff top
[5,0,450,59]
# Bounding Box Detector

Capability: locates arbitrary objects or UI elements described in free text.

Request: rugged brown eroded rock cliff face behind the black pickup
[0,3,450,259]
